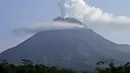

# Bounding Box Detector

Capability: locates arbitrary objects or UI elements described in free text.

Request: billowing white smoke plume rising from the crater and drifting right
[58,0,130,24]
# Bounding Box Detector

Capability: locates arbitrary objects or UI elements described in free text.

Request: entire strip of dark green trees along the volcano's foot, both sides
[0,59,130,73]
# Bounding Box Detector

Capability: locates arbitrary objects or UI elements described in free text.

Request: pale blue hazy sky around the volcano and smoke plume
[0,0,130,51]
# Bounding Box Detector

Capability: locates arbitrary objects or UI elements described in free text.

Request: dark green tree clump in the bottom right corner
[96,60,130,73]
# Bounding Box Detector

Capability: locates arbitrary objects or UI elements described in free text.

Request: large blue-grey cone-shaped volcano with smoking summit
[0,17,130,69]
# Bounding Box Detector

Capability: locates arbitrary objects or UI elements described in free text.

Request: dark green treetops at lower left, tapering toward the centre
[0,59,75,73]
